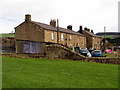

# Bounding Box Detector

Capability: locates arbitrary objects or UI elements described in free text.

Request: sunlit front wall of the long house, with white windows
[45,30,86,48]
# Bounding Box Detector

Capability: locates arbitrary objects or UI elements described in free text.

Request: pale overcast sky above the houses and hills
[0,0,120,33]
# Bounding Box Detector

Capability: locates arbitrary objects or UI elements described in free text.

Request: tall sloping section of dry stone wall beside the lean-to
[46,45,85,60]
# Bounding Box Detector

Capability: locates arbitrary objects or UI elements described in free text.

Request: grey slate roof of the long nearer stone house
[31,21,83,36]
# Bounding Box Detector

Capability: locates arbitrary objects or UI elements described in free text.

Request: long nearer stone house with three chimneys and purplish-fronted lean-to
[15,14,86,54]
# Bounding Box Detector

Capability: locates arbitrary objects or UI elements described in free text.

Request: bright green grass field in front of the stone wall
[2,57,118,88]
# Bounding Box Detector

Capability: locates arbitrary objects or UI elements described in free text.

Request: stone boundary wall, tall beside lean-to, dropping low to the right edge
[46,45,120,64]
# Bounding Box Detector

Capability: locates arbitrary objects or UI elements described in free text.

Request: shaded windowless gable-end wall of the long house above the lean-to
[15,22,44,42]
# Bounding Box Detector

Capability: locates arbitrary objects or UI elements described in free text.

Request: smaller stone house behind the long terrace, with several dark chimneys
[78,26,101,49]
